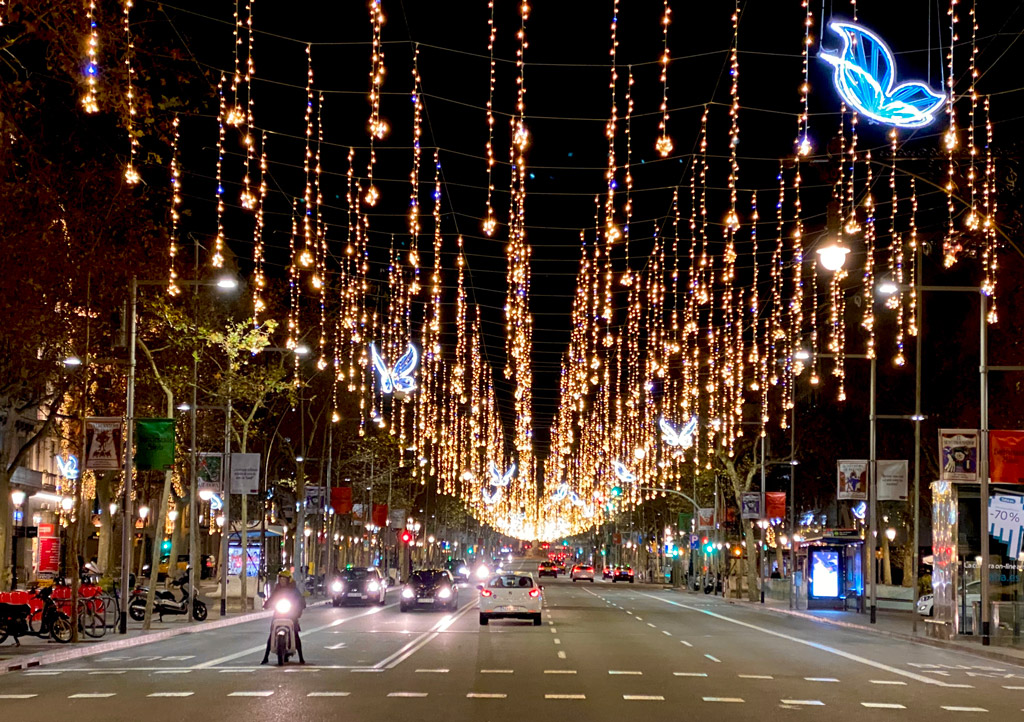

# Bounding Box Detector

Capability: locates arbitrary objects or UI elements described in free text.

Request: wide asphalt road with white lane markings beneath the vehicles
[0,562,1024,722]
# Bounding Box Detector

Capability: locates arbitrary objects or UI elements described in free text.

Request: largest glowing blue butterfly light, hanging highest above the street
[818,22,946,128]
